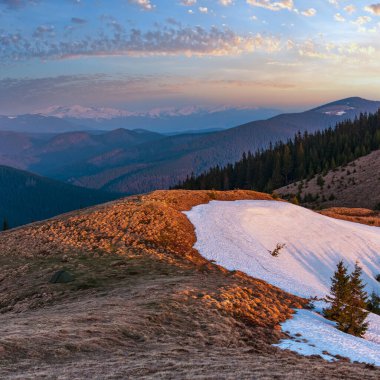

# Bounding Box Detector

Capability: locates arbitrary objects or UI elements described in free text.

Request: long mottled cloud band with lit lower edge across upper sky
[0,20,281,63]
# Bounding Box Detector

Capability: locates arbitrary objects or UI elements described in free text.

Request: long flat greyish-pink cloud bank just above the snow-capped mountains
[0,74,294,114]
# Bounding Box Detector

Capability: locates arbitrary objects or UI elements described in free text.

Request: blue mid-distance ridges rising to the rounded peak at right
[0,98,380,194]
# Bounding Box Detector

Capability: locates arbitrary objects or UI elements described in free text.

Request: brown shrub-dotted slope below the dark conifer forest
[275,150,380,209]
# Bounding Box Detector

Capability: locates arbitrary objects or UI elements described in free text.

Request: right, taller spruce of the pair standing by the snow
[338,263,369,337]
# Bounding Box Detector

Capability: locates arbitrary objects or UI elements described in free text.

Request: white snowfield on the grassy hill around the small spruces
[185,201,380,365]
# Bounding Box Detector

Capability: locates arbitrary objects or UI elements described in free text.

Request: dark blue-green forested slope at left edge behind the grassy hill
[0,166,117,230]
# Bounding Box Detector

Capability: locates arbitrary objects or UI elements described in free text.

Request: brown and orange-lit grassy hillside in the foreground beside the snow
[0,191,380,379]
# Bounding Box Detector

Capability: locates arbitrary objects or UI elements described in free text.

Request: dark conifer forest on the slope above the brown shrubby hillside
[175,110,380,193]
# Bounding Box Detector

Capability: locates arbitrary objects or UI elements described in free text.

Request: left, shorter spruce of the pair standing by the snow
[323,260,350,323]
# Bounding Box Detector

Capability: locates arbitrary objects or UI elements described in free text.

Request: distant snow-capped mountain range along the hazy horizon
[0,105,280,134]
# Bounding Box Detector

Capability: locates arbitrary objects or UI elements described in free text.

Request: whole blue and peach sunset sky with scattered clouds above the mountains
[0,0,380,115]
